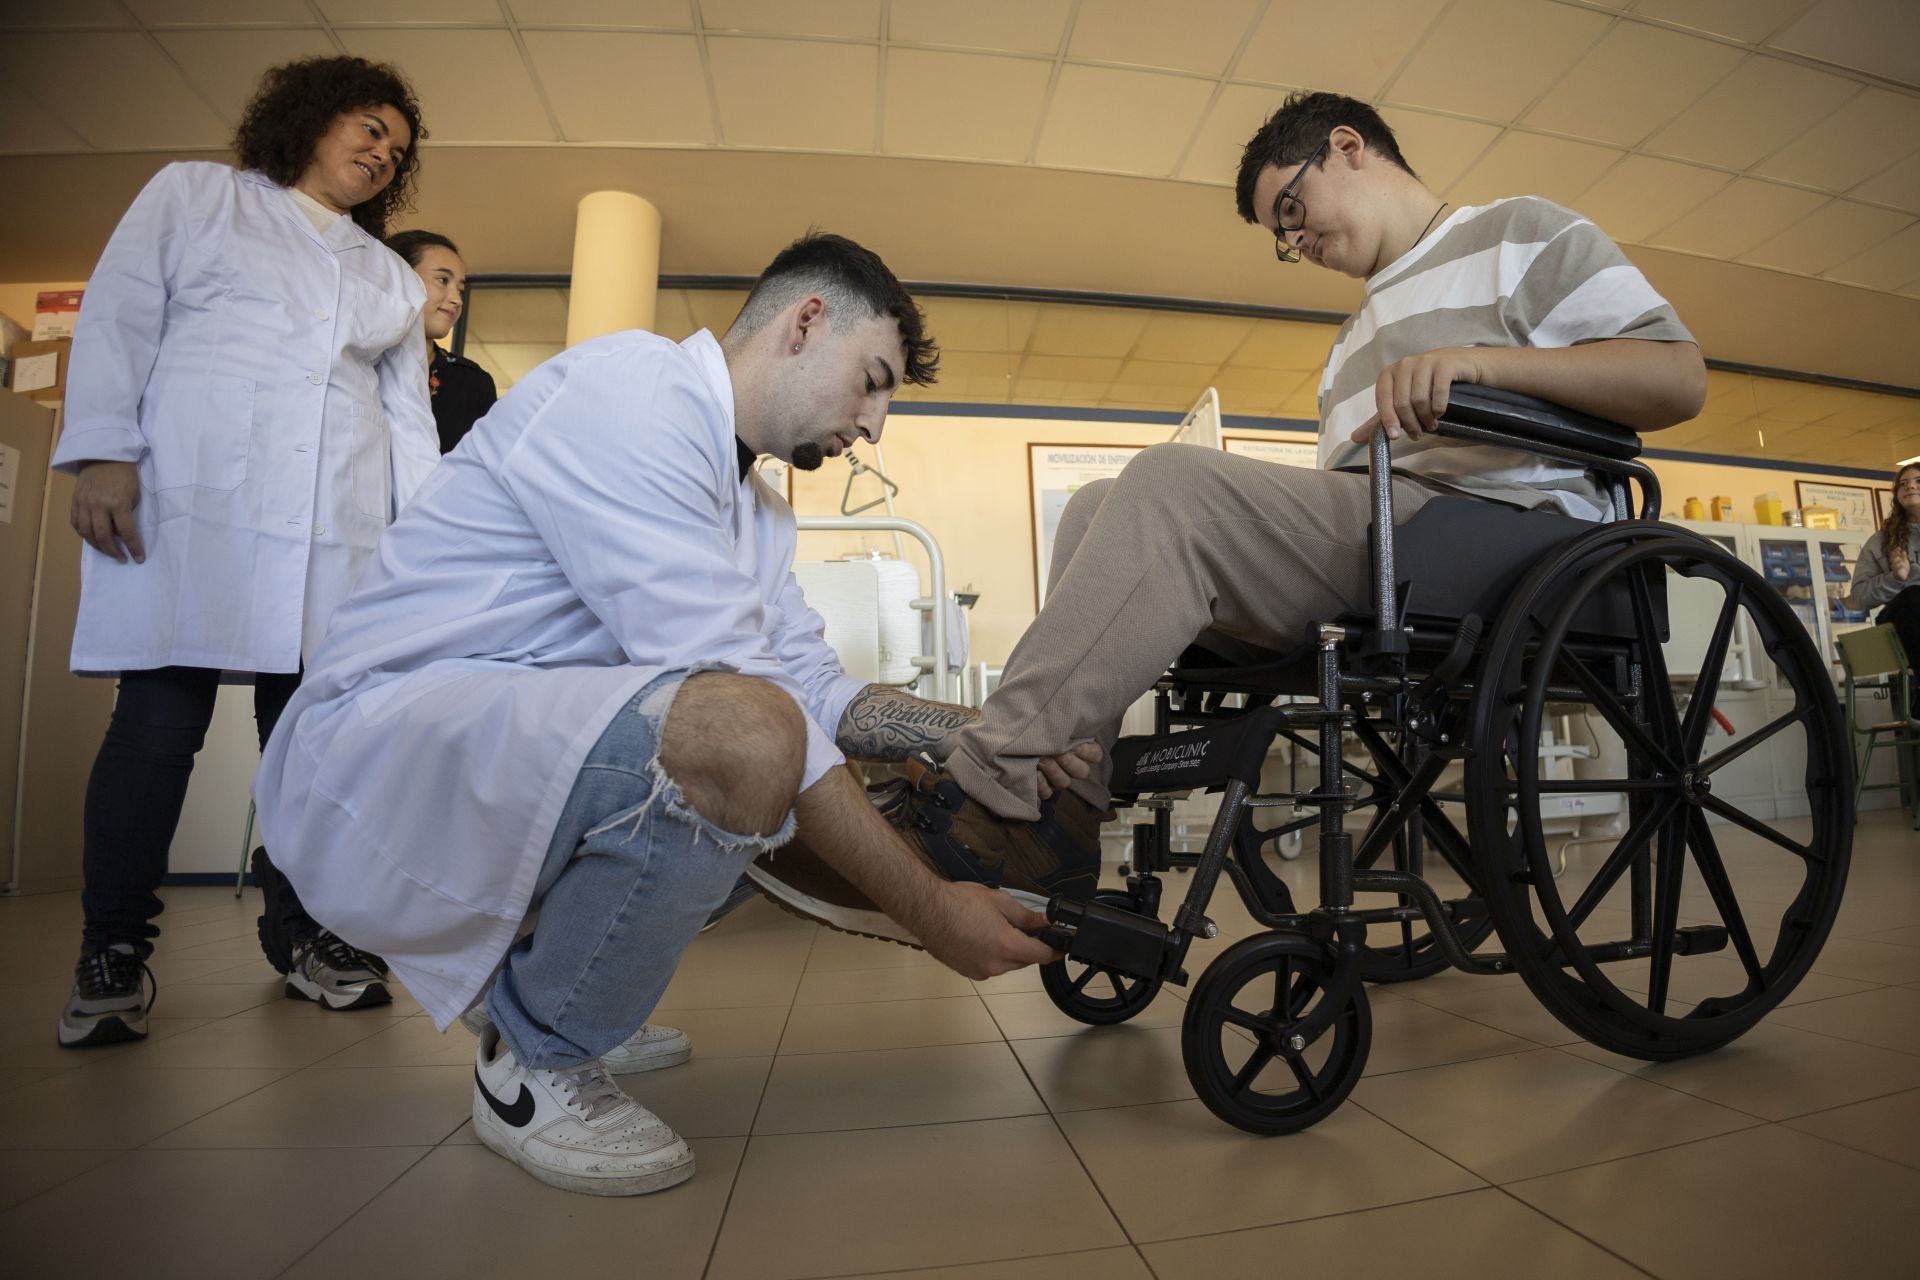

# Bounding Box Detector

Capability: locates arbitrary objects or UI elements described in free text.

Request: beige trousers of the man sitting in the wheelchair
[941,445,1440,819]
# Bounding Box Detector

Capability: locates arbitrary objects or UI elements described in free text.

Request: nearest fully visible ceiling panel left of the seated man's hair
[1035,65,1213,175]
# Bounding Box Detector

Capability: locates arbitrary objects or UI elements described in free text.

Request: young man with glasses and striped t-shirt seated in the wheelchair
[753,94,1707,927]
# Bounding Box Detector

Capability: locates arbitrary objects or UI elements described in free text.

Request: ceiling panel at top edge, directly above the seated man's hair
[1235,0,1446,100]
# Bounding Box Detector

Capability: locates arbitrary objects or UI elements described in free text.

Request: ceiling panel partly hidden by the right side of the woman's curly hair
[340,27,555,146]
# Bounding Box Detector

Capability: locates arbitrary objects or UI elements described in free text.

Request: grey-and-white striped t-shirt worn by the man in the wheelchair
[1319,196,1693,520]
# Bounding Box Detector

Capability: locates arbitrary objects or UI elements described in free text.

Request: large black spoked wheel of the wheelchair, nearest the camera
[1467,522,1853,1059]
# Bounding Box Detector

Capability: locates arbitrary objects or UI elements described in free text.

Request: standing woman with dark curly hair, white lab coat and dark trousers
[54,58,440,1046]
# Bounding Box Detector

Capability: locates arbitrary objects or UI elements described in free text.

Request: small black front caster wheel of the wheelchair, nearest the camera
[1181,933,1373,1134]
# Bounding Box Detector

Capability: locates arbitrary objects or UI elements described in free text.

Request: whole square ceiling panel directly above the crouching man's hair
[707,36,879,152]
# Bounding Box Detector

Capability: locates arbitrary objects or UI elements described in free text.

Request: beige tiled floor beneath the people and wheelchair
[0,812,1920,1280]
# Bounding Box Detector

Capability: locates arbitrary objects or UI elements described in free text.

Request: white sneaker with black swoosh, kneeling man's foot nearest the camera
[474,1025,693,1196]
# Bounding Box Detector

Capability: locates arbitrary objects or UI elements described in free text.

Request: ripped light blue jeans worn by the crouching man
[486,672,793,1071]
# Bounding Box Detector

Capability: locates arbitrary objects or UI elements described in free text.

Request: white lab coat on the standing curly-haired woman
[54,161,440,672]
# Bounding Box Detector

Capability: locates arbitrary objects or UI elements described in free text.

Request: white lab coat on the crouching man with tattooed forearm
[253,330,864,1027]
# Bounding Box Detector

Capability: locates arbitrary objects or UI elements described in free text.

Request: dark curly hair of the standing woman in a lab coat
[234,58,426,240]
